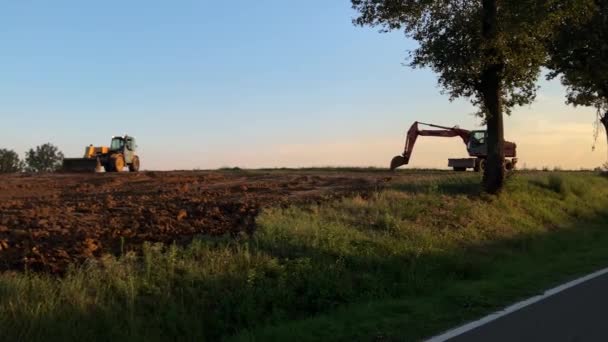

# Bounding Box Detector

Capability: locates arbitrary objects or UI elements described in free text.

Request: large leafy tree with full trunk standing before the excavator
[351,0,589,194]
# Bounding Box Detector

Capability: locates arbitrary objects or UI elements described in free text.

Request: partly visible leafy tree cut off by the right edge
[548,0,608,160]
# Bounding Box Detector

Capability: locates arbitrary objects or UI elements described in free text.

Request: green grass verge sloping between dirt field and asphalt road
[0,172,608,341]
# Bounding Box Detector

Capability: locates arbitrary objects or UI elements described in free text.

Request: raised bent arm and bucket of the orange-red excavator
[391,121,471,170]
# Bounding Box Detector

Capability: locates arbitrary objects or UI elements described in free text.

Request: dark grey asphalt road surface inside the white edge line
[448,274,608,342]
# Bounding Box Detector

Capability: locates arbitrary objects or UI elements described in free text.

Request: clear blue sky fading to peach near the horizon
[0,0,607,169]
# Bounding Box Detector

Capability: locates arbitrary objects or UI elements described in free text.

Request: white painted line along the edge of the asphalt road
[426,268,608,342]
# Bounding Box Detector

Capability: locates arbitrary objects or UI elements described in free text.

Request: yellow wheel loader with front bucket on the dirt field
[63,135,139,172]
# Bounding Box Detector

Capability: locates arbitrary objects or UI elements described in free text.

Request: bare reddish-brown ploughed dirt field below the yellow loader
[0,171,390,273]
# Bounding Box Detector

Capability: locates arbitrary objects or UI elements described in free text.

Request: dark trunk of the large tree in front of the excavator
[481,0,505,194]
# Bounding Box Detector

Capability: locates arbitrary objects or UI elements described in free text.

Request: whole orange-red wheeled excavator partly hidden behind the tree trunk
[391,121,517,172]
